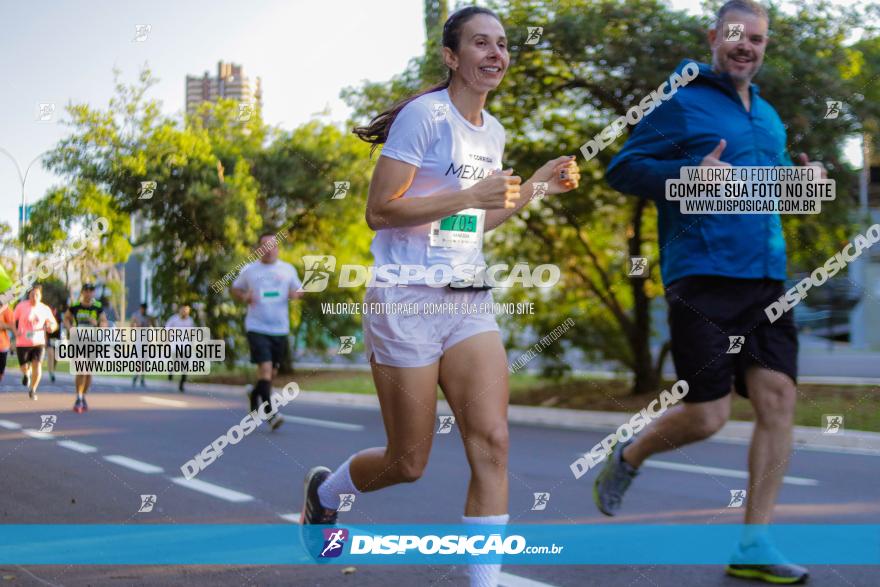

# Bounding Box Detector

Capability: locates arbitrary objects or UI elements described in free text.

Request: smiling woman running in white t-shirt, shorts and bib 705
[301,7,580,587]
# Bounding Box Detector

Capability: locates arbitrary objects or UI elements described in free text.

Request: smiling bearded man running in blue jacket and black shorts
[594,0,824,584]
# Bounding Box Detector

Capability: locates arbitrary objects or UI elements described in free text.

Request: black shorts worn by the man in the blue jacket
[666,275,798,402]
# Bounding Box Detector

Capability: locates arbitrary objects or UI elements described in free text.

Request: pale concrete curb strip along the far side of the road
[74,373,880,456]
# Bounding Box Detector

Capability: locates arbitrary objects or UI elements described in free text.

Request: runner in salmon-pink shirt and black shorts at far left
[13,285,58,400]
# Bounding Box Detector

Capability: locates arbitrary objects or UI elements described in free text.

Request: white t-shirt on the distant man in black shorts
[232,261,302,336]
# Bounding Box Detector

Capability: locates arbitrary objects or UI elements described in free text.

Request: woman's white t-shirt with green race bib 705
[370,90,505,283]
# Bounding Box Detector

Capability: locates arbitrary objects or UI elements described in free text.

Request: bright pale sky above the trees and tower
[0,0,868,230]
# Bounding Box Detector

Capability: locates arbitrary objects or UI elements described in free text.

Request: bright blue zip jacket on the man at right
[606,60,792,285]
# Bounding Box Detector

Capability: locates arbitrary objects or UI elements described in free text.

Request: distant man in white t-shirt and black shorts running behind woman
[231,232,303,430]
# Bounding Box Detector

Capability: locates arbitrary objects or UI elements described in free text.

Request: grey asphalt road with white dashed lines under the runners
[0,370,880,587]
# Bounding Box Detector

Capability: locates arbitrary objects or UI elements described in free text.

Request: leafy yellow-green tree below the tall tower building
[26,69,267,362]
